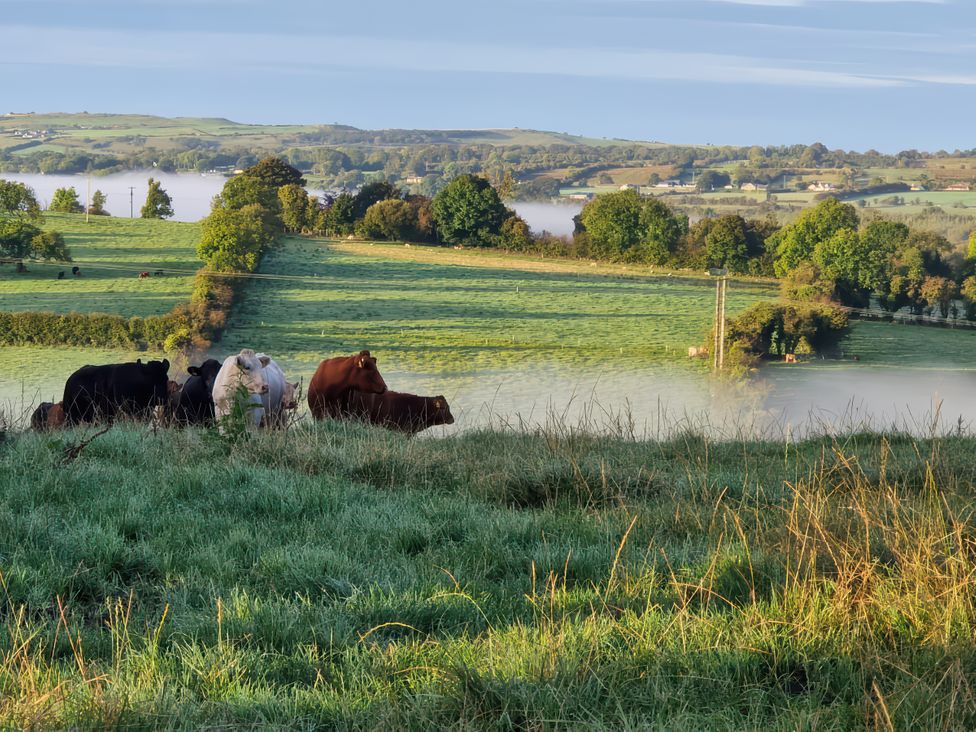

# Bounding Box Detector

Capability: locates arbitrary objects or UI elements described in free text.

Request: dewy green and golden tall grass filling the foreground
[0,424,976,729]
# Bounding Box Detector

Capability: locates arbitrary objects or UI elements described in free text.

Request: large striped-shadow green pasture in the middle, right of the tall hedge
[222,238,776,371]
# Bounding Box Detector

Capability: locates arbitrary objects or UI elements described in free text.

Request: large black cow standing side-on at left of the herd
[62,359,169,424]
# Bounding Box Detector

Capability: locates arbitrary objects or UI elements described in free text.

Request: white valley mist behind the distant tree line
[0,170,582,235]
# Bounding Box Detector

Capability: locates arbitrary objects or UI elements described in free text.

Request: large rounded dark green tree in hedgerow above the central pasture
[431,175,511,246]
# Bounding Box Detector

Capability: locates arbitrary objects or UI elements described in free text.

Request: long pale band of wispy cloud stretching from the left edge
[0,26,906,88]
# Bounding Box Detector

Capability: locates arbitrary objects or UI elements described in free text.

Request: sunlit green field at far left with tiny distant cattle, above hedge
[0,213,200,317]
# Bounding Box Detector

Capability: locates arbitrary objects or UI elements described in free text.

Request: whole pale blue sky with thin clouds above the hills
[0,0,976,151]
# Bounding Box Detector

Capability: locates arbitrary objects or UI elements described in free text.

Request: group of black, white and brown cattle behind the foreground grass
[31,349,454,434]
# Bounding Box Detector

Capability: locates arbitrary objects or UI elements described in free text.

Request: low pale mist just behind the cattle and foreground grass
[7,349,976,439]
